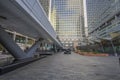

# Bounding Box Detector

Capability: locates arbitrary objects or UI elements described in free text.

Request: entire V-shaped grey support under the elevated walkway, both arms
[0,26,43,60]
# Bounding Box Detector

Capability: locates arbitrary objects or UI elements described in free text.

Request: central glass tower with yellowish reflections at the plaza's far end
[50,0,85,47]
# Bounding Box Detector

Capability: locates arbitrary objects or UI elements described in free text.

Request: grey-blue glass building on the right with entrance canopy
[86,0,120,53]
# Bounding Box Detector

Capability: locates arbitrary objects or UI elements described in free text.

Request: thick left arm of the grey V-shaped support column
[0,26,26,60]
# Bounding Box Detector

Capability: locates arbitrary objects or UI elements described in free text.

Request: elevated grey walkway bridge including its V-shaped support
[0,0,62,74]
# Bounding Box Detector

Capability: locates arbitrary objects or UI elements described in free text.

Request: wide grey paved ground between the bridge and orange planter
[0,53,120,80]
